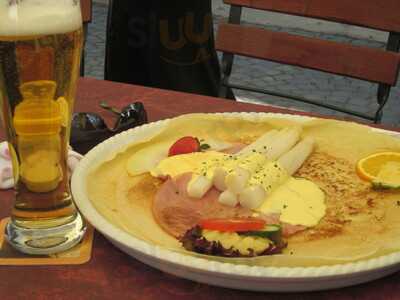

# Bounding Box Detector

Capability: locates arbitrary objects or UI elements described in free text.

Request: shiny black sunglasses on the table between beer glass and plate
[70,102,147,154]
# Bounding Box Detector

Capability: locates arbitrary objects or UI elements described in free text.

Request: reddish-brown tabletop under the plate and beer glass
[0,78,400,300]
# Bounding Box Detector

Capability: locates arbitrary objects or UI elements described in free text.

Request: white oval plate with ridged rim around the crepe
[72,113,400,292]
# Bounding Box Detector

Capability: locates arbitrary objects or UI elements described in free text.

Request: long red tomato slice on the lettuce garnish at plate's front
[199,218,266,232]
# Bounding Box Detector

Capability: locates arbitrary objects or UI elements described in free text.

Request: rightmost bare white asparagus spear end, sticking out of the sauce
[278,137,315,175]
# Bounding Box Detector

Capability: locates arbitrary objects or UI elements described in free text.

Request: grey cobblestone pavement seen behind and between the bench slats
[86,4,400,126]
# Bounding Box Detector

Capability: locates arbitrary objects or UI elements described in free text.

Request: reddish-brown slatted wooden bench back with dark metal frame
[216,0,400,122]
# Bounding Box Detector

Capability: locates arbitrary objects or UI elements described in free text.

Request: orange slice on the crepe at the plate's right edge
[356,152,400,181]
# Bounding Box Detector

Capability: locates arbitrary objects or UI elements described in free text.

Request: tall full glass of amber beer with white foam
[0,0,86,255]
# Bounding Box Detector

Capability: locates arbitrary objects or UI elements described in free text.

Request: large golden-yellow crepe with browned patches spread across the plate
[87,114,400,267]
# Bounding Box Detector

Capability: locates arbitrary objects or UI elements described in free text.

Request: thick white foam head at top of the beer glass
[0,0,82,37]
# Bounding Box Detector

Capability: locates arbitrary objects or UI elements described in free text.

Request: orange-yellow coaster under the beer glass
[0,218,94,266]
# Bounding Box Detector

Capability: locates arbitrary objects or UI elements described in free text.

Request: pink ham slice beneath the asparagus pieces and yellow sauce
[153,173,306,238]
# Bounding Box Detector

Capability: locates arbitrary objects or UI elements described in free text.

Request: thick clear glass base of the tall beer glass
[6,213,86,255]
